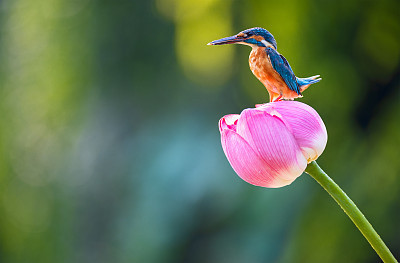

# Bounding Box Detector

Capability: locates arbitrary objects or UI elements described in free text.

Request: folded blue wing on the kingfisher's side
[266,47,301,95]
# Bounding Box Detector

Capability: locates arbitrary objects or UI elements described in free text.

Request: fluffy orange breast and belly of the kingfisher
[249,47,299,99]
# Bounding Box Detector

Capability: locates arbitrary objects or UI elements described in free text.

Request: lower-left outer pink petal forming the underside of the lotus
[221,129,295,188]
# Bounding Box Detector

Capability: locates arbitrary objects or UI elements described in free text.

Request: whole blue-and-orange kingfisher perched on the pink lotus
[208,27,321,102]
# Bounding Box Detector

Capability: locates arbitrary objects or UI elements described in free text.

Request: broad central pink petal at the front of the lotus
[237,109,307,181]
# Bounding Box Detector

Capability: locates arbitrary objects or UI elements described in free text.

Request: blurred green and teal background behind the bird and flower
[0,0,400,263]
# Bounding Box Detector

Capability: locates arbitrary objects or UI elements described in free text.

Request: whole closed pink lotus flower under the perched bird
[219,101,328,188]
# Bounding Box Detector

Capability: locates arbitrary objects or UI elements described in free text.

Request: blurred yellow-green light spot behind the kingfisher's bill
[157,0,233,88]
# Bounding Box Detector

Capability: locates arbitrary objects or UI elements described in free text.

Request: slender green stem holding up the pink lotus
[305,161,397,263]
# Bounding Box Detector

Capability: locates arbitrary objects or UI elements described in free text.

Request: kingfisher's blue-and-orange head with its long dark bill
[208,27,276,49]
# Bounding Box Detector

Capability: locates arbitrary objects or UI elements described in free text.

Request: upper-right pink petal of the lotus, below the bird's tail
[258,101,328,162]
